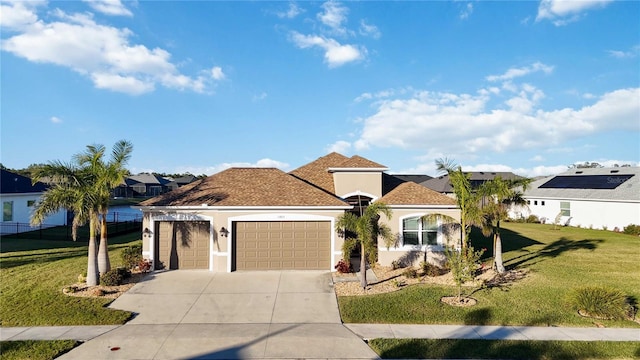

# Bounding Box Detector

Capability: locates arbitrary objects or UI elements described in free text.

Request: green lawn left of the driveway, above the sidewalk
[0,234,139,326]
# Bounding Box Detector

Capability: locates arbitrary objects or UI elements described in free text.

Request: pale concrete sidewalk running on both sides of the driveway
[0,324,640,342]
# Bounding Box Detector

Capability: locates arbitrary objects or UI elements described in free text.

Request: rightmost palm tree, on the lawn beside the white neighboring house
[479,176,530,274]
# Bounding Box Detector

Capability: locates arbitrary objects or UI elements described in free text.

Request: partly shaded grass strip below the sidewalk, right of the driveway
[369,339,640,360]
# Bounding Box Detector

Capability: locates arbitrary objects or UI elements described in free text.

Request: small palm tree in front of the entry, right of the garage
[336,202,395,289]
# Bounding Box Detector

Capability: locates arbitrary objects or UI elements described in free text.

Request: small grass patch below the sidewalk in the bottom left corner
[0,340,79,360]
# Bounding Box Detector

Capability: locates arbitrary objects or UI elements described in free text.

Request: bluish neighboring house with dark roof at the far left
[0,170,67,234]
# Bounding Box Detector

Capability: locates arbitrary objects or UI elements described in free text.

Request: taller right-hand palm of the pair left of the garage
[75,140,133,274]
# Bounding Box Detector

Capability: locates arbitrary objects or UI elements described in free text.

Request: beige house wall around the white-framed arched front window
[378,207,460,266]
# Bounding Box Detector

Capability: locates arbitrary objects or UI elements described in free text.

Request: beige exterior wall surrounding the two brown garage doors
[142,209,344,272]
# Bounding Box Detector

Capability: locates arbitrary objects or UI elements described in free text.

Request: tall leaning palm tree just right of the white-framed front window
[436,158,482,248]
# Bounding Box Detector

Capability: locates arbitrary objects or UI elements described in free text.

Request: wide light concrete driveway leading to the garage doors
[60,270,377,359]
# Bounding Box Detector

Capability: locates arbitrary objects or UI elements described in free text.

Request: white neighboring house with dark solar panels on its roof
[511,167,640,230]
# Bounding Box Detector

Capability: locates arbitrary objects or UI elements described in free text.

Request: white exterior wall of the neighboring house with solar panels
[510,197,640,231]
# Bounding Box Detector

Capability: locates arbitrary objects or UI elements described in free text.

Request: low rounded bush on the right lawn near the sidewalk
[567,286,635,319]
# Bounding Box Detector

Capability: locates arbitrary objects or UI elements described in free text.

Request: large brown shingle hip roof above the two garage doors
[140,168,348,206]
